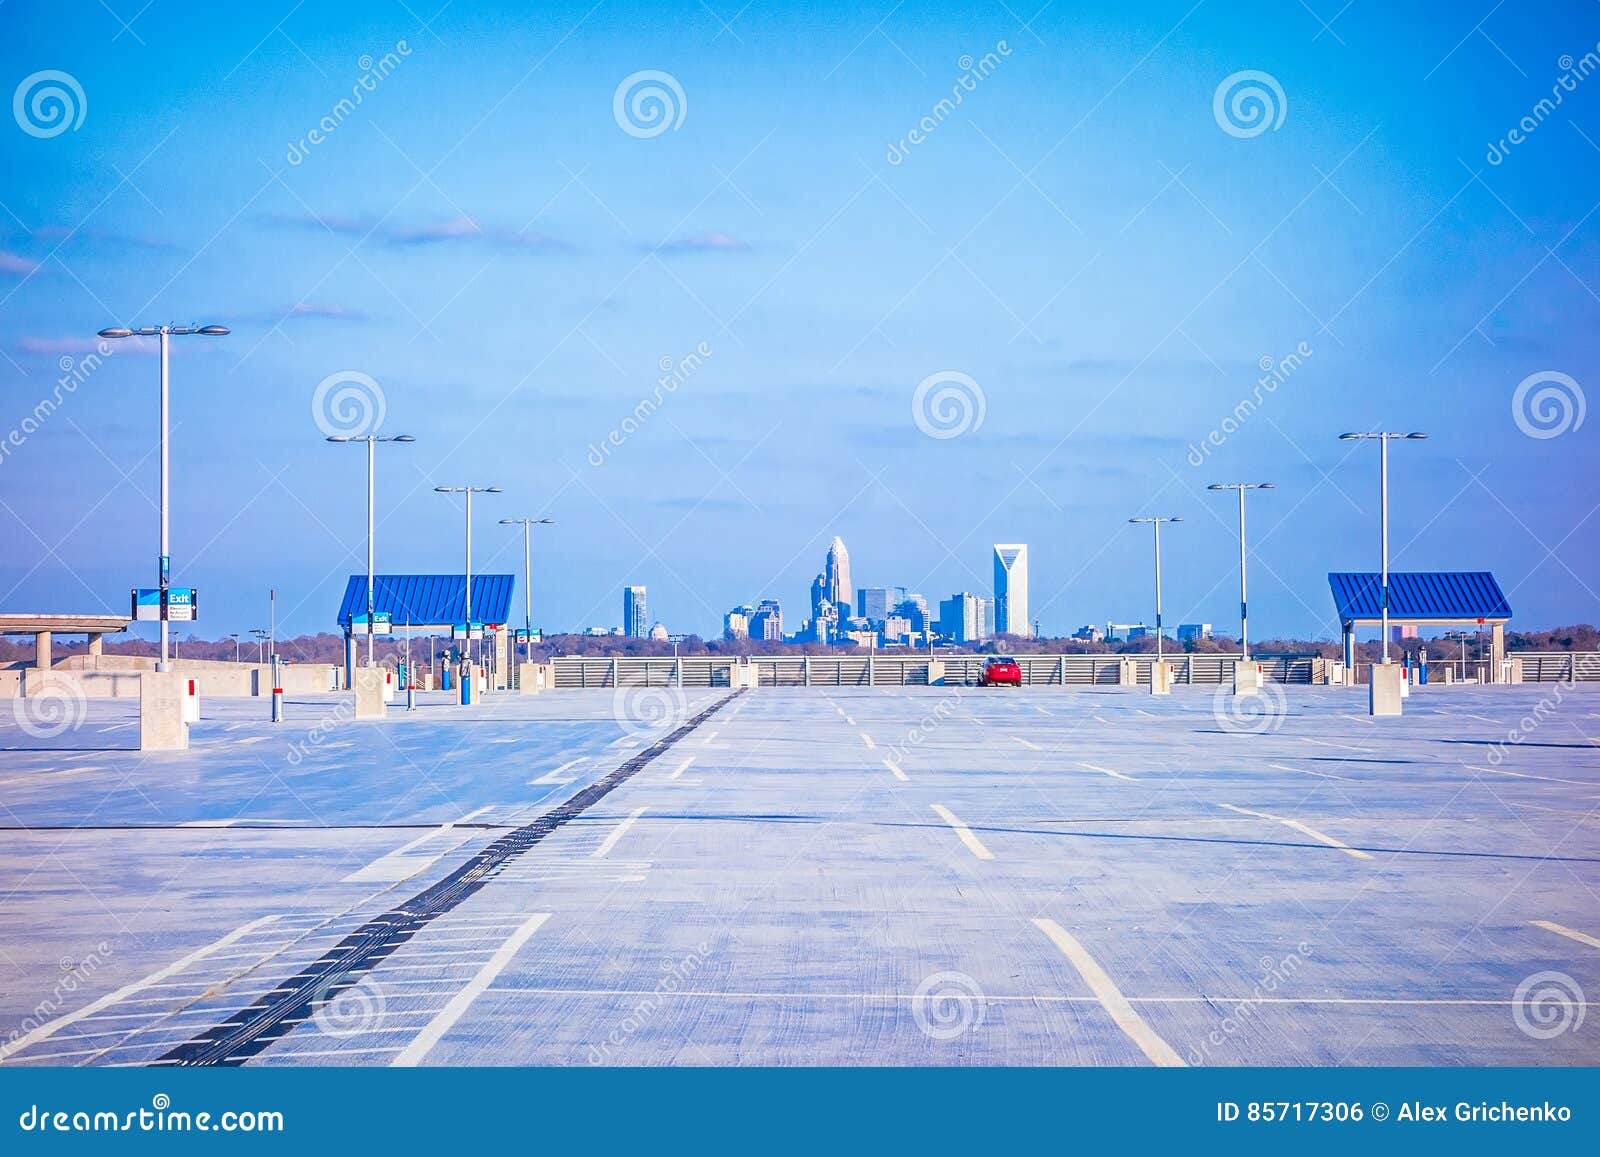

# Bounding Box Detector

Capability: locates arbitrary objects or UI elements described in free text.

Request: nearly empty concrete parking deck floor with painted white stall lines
[0,685,1600,1066]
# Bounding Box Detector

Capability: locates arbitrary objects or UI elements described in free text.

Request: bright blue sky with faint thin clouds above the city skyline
[0,0,1600,637]
